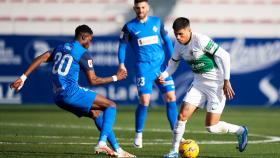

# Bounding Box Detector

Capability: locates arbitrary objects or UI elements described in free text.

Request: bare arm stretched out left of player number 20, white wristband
[10,51,51,92]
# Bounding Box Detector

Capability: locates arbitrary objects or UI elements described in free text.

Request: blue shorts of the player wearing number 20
[54,87,97,117]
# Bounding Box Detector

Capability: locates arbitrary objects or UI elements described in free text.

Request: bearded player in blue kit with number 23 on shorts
[118,0,178,148]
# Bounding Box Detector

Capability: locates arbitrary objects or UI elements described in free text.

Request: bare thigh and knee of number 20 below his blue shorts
[91,94,116,110]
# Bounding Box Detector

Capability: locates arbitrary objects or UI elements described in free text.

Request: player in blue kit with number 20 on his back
[10,25,135,157]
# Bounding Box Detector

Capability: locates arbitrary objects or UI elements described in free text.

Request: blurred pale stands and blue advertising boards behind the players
[0,0,280,106]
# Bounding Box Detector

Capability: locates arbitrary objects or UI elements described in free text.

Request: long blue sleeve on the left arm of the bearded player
[118,25,130,64]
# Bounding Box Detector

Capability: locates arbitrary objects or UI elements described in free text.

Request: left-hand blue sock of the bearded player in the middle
[135,104,148,133]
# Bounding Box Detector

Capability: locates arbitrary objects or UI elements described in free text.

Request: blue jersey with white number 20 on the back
[51,41,93,96]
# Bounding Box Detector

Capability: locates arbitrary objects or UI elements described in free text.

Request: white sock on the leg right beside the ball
[172,120,187,152]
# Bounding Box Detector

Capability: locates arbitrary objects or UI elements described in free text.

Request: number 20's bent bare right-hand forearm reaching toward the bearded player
[86,70,127,86]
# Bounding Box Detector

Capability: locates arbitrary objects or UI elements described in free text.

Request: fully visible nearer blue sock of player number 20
[99,107,116,142]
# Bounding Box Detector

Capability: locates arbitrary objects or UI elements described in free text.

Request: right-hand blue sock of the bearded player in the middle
[166,101,178,130]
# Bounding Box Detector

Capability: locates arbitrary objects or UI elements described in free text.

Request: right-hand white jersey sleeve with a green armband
[199,35,219,55]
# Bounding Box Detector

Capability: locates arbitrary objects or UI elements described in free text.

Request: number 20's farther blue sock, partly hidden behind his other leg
[94,113,120,151]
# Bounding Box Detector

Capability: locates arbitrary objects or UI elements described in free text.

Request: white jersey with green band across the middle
[172,32,224,82]
